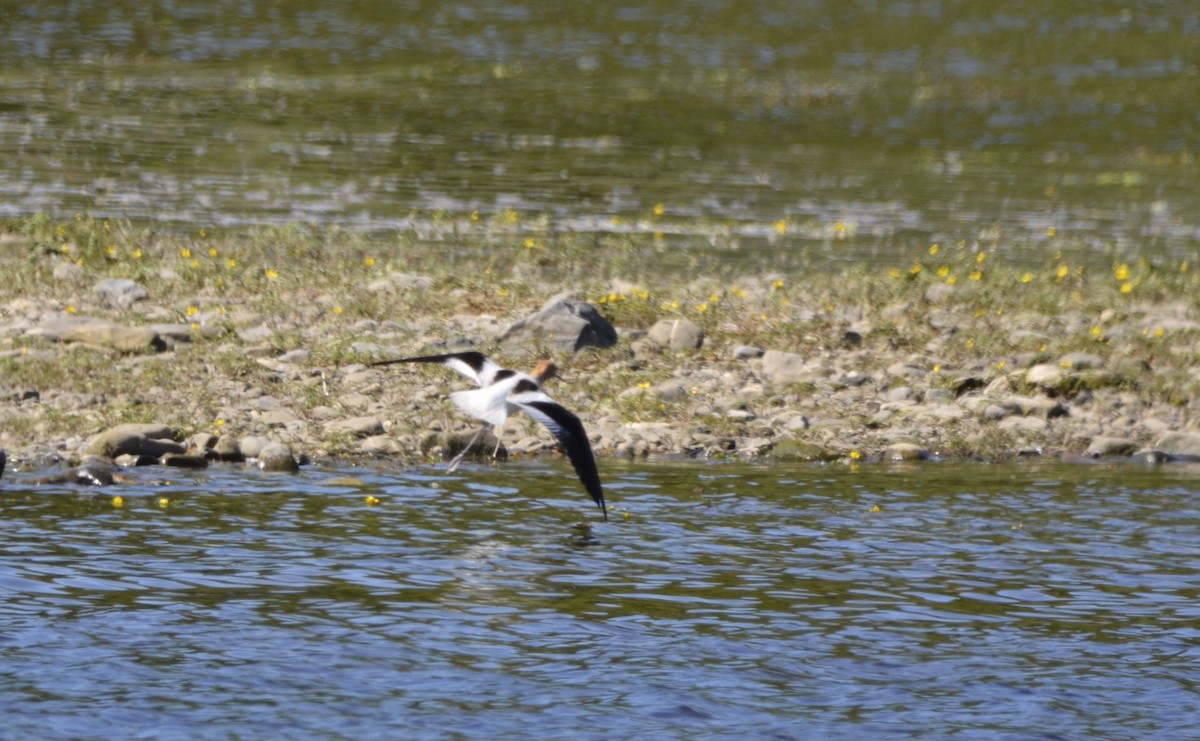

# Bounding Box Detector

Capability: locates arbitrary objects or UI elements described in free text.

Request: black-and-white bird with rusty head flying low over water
[370,350,608,520]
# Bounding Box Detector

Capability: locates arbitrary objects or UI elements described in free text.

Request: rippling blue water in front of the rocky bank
[0,460,1200,739]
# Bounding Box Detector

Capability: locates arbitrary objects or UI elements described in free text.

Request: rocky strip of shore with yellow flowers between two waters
[0,226,1200,483]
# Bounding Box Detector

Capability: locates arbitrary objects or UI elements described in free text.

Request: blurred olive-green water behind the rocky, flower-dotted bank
[0,0,1200,266]
